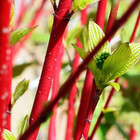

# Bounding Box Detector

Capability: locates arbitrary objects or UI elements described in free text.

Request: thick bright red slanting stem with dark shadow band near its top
[30,0,72,140]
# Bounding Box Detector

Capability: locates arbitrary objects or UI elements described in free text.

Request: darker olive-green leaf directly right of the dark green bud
[102,43,131,80]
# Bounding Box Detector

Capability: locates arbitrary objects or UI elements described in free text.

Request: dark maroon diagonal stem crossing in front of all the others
[19,0,139,140]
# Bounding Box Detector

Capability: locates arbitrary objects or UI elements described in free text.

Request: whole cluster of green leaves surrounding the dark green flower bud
[73,21,140,91]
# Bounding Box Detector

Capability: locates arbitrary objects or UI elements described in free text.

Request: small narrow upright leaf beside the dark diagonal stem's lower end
[19,115,29,136]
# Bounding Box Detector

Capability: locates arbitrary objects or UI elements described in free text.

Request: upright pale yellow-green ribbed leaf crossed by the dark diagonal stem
[88,21,111,57]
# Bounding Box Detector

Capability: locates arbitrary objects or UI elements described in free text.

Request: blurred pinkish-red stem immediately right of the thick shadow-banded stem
[48,44,64,140]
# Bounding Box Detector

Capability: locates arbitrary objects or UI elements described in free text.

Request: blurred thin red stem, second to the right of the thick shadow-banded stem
[65,6,88,140]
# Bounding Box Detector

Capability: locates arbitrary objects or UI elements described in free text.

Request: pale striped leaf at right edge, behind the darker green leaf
[110,43,140,80]
